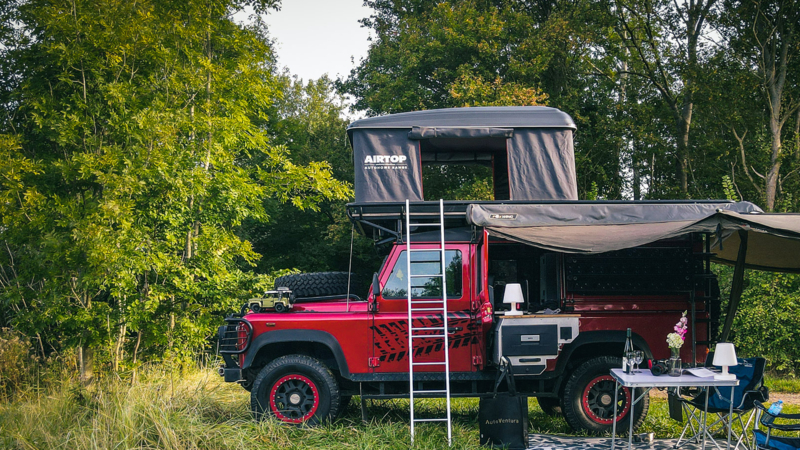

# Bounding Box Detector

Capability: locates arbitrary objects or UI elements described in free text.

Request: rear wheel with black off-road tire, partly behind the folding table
[564,356,650,434]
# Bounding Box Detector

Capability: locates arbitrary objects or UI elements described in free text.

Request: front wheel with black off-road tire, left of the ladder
[250,355,341,426]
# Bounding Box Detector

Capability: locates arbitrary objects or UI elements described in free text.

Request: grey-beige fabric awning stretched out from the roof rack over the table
[467,202,800,273]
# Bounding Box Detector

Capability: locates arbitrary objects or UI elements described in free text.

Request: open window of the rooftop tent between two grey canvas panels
[419,137,510,200]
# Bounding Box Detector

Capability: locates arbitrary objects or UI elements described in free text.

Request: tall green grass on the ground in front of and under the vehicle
[0,370,800,450]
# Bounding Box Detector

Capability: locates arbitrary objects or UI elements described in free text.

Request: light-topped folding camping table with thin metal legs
[611,369,739,450]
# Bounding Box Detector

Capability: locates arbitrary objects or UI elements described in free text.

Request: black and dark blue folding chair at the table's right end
[675,358,769,450]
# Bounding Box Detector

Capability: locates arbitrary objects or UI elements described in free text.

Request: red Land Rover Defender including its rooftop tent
[219,107,757,432]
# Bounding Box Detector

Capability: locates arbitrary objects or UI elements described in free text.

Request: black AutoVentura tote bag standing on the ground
[478,358,528,449]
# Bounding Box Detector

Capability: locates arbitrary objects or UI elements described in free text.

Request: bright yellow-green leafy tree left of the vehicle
[0,0,349,376]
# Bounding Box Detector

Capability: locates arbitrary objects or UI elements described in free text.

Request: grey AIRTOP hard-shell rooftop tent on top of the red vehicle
[347,106,578,203]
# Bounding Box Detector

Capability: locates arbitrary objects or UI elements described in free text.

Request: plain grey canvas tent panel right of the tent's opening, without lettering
[508,128,578,200]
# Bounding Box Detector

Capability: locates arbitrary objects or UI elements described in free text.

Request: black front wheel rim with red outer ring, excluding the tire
[269,374,319,423]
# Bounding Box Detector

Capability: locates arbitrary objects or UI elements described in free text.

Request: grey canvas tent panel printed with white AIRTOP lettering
[353,129,423,202]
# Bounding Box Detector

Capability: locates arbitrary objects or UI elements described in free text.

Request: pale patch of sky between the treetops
[265,0,372,81]
